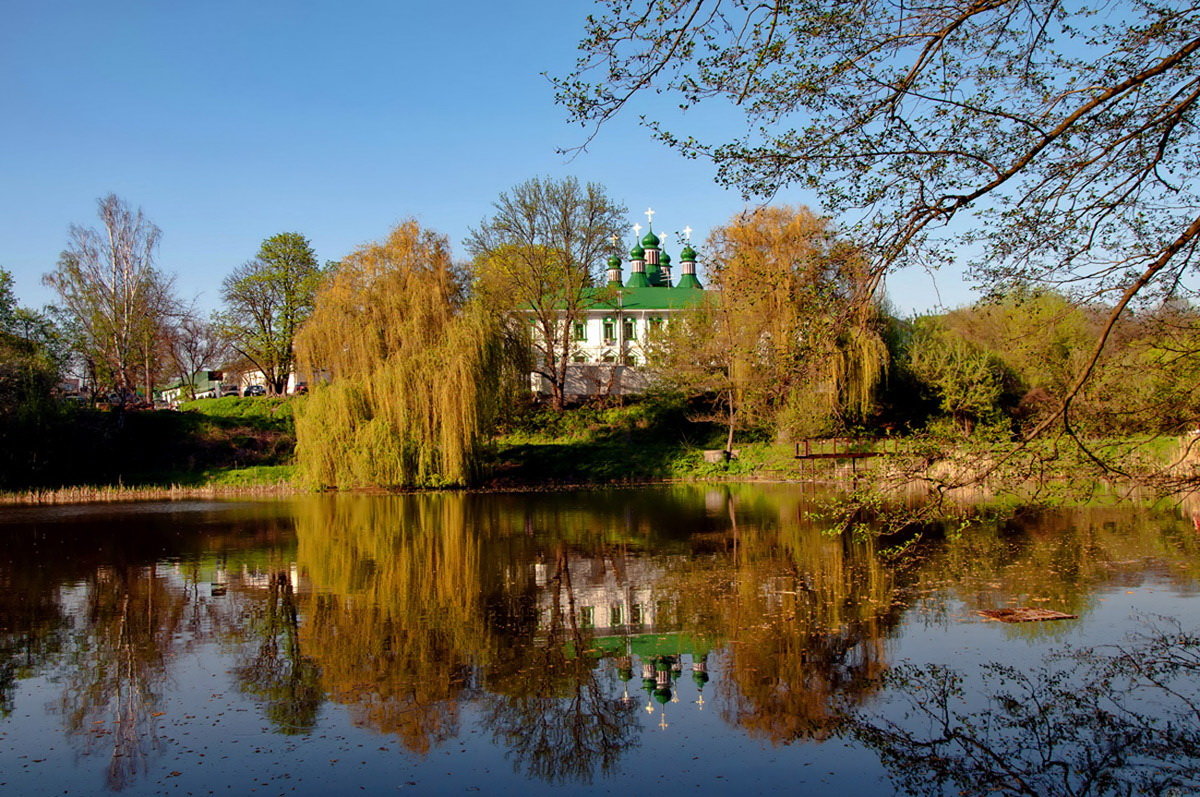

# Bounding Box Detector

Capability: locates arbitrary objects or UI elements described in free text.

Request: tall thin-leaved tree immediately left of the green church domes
[466,178,625,408]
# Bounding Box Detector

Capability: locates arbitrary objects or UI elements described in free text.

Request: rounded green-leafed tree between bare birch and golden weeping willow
[220,233,322,395]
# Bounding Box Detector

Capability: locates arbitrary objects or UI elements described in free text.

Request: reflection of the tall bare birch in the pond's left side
[62,565,187,789]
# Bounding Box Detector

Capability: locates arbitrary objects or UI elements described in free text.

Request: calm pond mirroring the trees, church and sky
[0,485,1200,795]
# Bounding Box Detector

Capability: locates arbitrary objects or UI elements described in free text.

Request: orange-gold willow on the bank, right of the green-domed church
[653,206,888,445]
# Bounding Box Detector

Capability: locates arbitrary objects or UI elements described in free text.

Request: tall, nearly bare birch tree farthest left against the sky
[43,194,176,402]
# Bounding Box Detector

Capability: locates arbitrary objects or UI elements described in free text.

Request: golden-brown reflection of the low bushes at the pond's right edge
[918,508,1200,635]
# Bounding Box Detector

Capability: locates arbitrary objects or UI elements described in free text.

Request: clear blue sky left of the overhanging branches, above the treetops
[0,0,970,312]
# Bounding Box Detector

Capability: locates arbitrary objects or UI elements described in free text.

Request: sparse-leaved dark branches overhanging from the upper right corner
[557,0,1200,444]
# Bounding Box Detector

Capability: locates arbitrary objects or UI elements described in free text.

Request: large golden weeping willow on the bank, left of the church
[296,221,511,487]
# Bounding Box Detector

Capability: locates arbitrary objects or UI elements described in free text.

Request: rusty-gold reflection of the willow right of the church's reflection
[678,496,898,742]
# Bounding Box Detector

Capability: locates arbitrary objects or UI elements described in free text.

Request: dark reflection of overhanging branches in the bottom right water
[847,627,1200,797]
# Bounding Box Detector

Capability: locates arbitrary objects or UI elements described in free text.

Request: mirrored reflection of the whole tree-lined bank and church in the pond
[0,486,1200,790]
